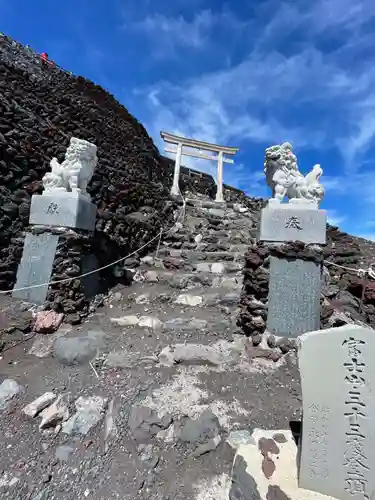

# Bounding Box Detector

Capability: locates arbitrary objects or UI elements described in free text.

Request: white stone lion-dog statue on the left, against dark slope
[42,137,98,200]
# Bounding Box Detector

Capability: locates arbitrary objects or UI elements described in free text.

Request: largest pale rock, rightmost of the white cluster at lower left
[62,396,107,435]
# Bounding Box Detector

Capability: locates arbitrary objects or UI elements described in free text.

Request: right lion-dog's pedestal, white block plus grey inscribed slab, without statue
[260,203,327,337]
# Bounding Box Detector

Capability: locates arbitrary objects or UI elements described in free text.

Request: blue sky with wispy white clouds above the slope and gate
[0,0,375,239]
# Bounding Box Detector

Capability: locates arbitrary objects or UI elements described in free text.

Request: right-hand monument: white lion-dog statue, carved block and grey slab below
[259,143,327,337]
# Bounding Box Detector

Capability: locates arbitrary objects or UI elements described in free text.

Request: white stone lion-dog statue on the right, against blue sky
[264,142,324,207]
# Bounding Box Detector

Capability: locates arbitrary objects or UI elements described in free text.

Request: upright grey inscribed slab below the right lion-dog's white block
[267,257,322,337]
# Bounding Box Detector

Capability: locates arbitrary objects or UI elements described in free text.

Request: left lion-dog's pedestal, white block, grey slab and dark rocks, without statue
[12,192,97,304]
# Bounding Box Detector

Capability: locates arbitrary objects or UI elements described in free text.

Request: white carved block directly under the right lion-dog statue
[259,203,327,244]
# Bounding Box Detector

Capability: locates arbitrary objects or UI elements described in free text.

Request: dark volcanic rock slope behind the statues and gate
[0,36,375,332]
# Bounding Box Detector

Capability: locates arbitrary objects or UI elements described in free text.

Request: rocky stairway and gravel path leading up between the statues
[0,196,300,500]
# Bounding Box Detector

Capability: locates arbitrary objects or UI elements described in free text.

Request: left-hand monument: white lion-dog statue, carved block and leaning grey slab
[12,137,97,304]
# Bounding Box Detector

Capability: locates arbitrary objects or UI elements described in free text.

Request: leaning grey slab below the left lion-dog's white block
[12,233,59,304]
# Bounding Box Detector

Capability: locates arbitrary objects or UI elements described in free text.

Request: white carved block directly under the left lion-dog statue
[29,192,96,231]
